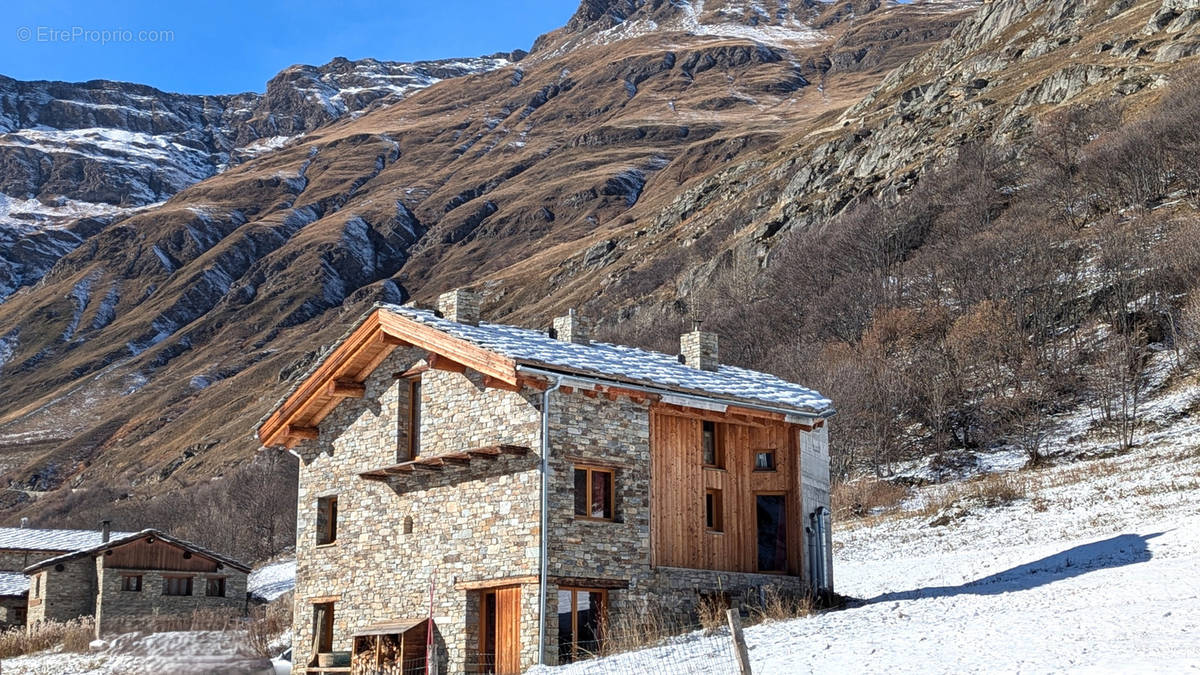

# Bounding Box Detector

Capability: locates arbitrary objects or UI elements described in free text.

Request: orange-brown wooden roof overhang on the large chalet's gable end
[258,309,521,448]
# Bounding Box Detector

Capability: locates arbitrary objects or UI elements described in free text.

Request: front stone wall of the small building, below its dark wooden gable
[96,558,246,634]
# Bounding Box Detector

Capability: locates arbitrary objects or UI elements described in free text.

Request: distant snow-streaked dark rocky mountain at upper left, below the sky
[0,53,511,301]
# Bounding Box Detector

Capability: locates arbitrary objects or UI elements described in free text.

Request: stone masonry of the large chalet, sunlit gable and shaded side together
[293,341,826,673]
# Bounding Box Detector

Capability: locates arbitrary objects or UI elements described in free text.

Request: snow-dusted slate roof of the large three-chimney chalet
[380,304,833,413]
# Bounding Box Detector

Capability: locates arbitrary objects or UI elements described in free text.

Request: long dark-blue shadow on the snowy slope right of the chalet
[865,532,1163,604]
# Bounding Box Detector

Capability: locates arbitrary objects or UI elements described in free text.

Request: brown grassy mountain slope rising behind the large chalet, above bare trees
[0,0,1196,530]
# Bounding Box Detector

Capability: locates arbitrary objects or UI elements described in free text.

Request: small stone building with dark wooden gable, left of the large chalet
[25,530,250,634]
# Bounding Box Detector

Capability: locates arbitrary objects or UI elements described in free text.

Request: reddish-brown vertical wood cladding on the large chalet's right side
[650,407,803,574]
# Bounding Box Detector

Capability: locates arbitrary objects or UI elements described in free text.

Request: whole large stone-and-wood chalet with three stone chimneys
[258,291,833,674]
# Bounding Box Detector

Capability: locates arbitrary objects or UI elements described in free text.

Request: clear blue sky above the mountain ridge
[0,0,578,94]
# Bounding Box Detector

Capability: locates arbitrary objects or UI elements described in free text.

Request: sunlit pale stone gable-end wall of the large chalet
[293,348,541,673]
